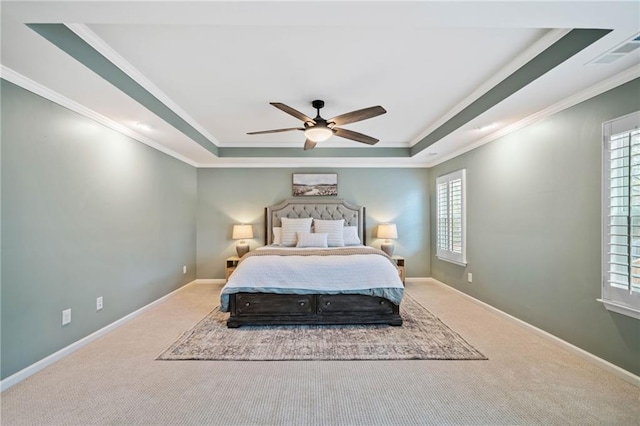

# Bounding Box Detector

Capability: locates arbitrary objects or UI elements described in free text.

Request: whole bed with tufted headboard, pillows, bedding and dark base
[220,199,404,328]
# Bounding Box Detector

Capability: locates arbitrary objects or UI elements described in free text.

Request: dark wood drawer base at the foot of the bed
[227,293,402,328]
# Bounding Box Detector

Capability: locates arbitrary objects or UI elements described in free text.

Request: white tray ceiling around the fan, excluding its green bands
[0,1,640,167]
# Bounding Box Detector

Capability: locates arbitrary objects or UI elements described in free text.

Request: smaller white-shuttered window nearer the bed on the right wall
[436,169,467,266]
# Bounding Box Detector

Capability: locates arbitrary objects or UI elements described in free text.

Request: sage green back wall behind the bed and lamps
[197,168,430,279]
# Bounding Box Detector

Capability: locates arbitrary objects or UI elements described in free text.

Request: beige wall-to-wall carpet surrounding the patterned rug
[0,282,640,426]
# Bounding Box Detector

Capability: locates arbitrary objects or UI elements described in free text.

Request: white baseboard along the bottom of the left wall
[0,280,197,392]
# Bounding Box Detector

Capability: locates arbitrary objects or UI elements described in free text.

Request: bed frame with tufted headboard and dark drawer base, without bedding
[227,198,402,328]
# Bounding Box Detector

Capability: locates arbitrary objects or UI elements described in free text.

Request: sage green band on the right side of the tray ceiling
[411,29,612,156]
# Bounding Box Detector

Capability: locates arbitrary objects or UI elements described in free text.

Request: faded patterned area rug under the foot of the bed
[156,294,487,361]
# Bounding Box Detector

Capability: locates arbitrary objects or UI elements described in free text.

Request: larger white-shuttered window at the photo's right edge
[599,112,640,319]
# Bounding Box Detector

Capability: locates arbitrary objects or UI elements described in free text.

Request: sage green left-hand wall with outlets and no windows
[0,80,197,379]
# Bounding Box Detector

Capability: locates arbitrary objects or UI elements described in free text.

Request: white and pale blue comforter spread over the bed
[220,246,404,312]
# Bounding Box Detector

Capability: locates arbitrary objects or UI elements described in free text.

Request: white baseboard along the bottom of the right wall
[427,278,640,387]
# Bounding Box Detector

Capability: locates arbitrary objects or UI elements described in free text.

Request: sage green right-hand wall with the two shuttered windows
[429,80,640,374]
